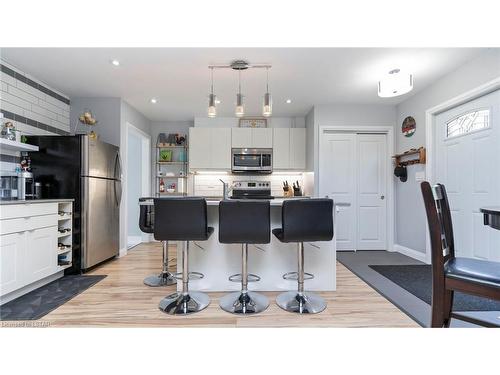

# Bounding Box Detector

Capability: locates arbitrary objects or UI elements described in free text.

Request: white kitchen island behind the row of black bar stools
[177,199,336,292]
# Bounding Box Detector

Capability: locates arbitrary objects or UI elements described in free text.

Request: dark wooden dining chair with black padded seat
[420,181,500,327]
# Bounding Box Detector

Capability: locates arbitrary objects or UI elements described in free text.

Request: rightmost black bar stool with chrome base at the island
[273,198,333,314]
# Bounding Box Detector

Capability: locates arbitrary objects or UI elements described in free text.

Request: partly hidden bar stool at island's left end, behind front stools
[139,198,177,287]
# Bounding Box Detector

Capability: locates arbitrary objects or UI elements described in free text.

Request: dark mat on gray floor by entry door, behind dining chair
[369,264,500,311]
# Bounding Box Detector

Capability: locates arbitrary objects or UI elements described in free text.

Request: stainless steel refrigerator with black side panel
[28,135,122,273]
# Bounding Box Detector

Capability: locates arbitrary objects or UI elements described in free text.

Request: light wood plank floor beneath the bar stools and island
[28,243,418,327]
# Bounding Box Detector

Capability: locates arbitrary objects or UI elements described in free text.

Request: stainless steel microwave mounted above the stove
[231,148,273,173]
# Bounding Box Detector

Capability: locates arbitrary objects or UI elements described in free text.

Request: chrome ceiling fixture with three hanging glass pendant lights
[207,60,272,117]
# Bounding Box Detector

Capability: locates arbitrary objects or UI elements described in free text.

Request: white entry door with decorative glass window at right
[435,91,500,260]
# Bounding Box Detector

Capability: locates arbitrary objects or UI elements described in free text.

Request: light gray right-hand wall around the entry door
[395,49,500,253]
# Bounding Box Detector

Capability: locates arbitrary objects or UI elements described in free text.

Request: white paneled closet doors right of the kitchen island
[319,133,387,250]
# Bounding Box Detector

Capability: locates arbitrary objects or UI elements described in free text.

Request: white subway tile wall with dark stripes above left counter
[0,60,70,135]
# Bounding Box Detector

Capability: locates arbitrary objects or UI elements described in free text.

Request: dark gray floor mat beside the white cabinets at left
[0,275,106,320]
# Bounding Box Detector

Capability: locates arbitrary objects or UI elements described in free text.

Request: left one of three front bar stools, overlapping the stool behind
[154,198,214,315]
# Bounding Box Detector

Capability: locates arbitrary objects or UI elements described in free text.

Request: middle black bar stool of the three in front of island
[219,200,271,315]
